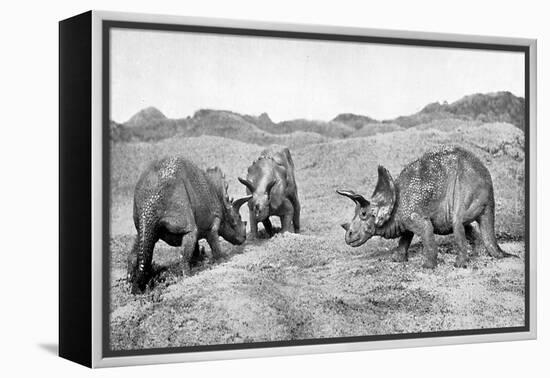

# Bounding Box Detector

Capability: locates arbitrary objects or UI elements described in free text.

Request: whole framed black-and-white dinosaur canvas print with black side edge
[59,11,537,367]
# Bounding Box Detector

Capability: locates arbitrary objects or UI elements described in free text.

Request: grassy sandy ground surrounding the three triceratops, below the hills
[106,124,525,350]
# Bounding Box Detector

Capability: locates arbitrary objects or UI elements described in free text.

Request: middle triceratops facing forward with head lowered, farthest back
[239,146,300,237]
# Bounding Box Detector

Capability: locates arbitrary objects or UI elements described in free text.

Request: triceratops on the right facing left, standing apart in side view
[337,146,513,268]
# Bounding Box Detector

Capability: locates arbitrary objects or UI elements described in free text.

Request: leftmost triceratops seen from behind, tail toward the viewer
[128,157,251,293]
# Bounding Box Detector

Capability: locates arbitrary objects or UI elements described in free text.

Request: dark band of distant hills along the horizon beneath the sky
[111,92,525,146]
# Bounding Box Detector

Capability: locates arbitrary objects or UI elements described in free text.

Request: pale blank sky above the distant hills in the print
[111,29,524,122]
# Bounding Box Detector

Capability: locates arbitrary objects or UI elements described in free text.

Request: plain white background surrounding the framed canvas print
[0,0,550,378]
